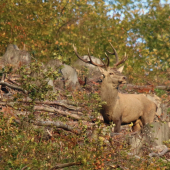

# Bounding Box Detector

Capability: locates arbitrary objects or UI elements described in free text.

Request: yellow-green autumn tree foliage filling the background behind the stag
[0,0,170,84]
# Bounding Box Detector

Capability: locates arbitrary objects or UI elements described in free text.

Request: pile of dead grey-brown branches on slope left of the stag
[0,71,98,137]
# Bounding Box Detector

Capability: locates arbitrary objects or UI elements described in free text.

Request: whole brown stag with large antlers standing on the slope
[73,43,157,133]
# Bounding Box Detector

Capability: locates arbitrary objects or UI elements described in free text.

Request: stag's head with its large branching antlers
[73,43,127,88]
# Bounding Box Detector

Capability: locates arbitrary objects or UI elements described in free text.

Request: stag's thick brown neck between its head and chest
[101,82,118,108]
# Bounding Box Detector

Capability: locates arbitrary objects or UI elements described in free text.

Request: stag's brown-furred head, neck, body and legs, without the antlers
[100,68,156,132]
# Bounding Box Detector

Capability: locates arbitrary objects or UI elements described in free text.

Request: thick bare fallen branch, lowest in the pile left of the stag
[31,121,81,134]
